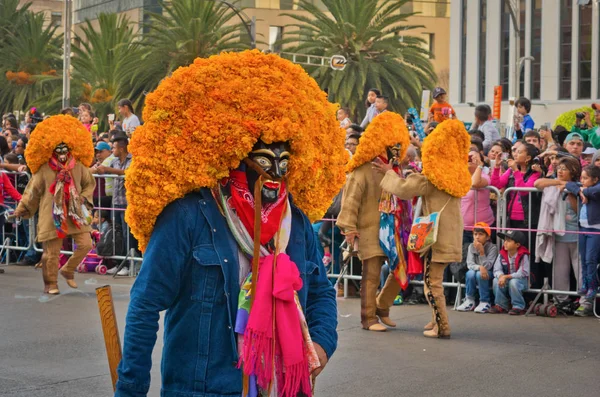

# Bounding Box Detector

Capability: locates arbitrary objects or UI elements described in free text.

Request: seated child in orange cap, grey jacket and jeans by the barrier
[457,222,498,313]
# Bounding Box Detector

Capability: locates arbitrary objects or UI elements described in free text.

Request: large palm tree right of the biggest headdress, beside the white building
[281,0,436,117]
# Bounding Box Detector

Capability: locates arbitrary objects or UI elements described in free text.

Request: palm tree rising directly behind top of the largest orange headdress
[125,0,249,98]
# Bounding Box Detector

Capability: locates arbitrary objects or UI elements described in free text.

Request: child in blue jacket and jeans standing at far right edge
[566,165,600,316]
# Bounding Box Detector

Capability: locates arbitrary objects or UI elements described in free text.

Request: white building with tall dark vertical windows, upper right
[449,0,600,126]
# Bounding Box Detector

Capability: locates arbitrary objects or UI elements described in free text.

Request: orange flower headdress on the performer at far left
[25,115,94,174]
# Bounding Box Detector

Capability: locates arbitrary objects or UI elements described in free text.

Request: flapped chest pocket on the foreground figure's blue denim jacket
[191,244,225,303]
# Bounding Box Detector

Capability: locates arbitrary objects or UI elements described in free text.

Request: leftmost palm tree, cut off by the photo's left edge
[0,5,62,112]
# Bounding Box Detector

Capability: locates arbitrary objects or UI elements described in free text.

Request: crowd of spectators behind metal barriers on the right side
[324,88,600,316]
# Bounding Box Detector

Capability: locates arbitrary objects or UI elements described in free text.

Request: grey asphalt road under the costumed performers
[0,266,600,397]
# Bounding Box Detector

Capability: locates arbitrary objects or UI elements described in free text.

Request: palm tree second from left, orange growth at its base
[72,14,142,128]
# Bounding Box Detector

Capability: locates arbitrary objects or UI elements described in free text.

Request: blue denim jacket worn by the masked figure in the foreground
[115,189,337,397]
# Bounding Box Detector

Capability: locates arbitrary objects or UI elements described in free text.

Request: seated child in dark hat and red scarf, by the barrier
[488,230,530,316]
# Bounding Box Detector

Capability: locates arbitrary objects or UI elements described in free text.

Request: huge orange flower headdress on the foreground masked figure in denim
[125,50,347,249]
